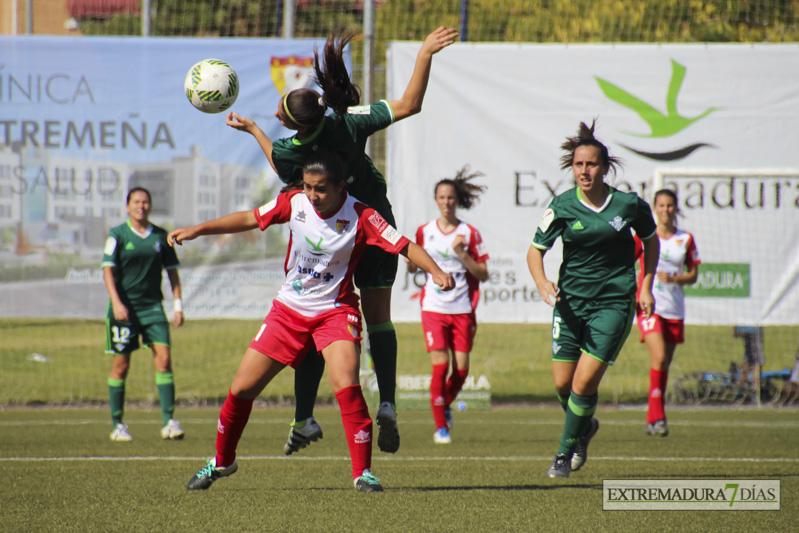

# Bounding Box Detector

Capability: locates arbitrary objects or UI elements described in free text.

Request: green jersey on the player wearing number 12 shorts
[102,220,180,307]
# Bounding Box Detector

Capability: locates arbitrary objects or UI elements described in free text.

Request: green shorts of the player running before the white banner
[552,297,635,365]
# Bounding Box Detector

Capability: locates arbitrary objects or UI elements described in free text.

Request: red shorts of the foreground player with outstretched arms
[250,300,362,368]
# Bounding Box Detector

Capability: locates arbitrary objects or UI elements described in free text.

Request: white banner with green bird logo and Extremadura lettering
[387,43,799,325]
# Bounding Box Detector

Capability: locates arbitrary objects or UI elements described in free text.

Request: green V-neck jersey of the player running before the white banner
[533,187,656,300]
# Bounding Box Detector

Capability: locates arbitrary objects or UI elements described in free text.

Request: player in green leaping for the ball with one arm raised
[226,26,458,455]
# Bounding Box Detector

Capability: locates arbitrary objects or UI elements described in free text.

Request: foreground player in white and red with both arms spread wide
[168,152,454,492]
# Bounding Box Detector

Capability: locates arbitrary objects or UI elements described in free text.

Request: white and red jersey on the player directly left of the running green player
[416,219,488,315]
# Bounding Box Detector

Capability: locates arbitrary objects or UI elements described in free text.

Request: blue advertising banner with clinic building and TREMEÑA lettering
[0,37,324,319]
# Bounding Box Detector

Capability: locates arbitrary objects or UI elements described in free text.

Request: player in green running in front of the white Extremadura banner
[527,123,660,477]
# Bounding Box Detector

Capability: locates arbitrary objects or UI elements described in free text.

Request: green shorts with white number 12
[105,302,170,355]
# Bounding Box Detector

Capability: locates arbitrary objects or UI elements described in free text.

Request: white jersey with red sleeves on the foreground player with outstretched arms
[255,190,410,316]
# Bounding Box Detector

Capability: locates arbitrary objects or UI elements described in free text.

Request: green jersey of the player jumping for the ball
[272,100,394,209]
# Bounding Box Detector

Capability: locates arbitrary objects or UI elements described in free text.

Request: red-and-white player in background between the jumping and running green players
[408,167,488,444]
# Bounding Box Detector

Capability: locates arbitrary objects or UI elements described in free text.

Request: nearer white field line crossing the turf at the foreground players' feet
[0,455,799,463]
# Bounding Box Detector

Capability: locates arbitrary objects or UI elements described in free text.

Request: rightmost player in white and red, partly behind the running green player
[635,189,702,437]
